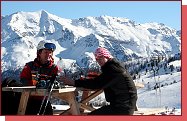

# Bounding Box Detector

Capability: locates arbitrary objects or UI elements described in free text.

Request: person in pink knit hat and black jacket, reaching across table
[64,48,137,115]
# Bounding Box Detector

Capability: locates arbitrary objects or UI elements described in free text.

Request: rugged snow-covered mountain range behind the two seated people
[1,10,181,72]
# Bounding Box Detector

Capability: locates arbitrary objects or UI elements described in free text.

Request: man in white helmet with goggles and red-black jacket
[20,41,58,115]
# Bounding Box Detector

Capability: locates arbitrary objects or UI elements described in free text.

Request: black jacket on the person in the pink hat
[75,59,137,109]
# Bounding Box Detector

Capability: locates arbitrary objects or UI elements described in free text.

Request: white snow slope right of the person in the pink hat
[135,60,181,109]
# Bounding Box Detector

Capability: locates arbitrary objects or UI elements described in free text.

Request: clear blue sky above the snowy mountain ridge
[1,1,181,30]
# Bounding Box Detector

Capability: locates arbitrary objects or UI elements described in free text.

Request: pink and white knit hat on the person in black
[94,47,113,59]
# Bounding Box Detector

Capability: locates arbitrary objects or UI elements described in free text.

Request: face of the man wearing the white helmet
[40,49,53,63]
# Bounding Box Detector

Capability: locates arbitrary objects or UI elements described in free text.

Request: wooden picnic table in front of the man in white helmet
[2,86,80,115]
